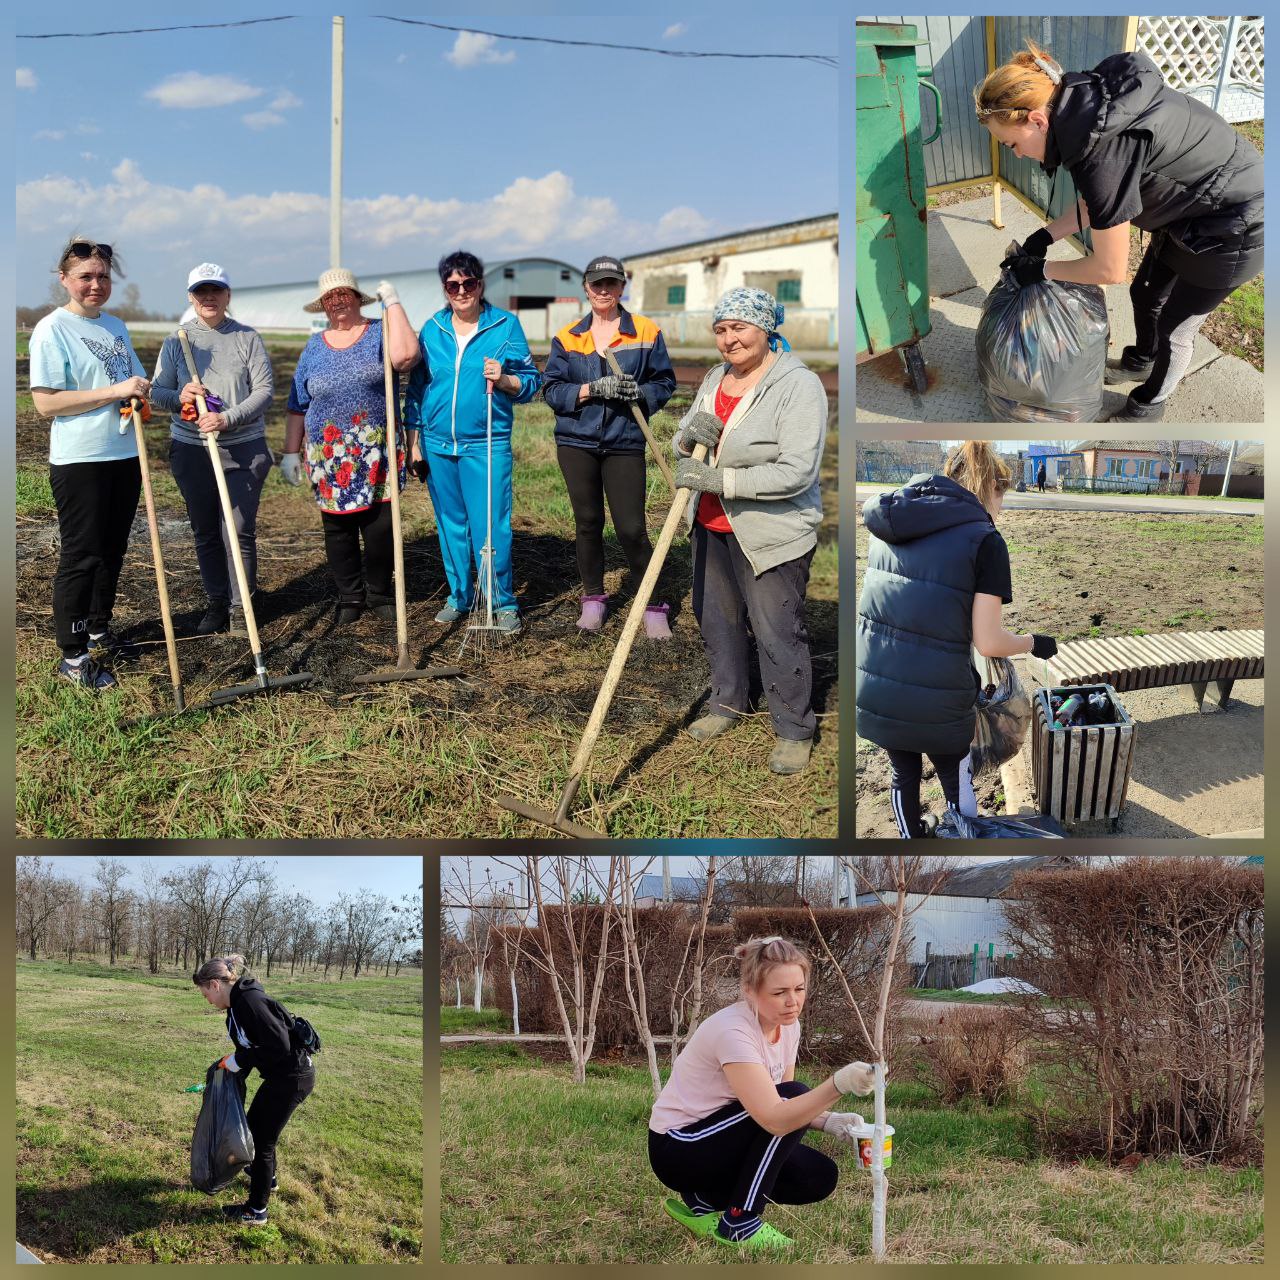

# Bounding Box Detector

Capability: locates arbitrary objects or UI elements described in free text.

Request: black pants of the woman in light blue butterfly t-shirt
[49,458,142,658]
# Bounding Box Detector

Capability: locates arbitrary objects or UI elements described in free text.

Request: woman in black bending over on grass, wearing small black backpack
[191,955,316,1222]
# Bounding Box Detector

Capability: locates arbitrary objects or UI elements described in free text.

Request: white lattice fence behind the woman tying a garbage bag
[1138,14,1263,120]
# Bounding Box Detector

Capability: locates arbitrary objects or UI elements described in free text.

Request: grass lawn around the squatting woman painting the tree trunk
[440,1043,1263,1265]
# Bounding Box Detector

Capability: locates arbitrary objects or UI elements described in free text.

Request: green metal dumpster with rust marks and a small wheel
[856,22,942,394]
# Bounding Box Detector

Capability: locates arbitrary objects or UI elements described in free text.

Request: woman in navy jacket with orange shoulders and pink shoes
[543,256,676,640]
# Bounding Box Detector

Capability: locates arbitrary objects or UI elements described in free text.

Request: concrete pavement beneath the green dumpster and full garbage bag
[855,193,1262,424]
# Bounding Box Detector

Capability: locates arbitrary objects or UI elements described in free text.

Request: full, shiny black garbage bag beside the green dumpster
[978,241,1107,422]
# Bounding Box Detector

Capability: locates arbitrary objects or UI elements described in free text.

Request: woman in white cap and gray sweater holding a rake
[151,262,274,635]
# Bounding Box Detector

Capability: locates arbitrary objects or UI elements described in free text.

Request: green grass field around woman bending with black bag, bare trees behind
[17,957,422,1265]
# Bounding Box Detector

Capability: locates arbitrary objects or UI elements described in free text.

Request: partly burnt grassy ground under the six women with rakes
[15,334,838,838]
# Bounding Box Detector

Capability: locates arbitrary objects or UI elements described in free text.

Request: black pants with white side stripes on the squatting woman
[649,1080,840,1216]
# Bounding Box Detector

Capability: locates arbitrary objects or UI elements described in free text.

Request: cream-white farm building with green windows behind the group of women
[623,214,840,351]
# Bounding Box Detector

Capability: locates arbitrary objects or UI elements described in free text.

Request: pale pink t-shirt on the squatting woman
[649,1000,800,1133]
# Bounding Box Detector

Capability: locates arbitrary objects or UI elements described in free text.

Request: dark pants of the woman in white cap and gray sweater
[169,438,271,604]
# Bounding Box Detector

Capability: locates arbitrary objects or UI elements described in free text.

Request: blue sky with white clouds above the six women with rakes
[15,6,838,311]
